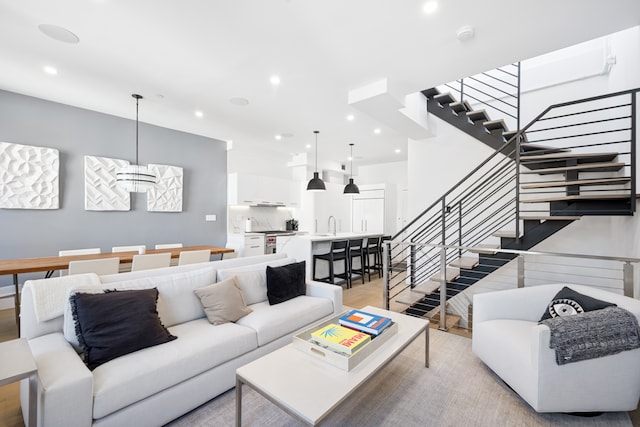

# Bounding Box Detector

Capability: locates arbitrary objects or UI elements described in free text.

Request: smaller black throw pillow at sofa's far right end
[267,261,307,305]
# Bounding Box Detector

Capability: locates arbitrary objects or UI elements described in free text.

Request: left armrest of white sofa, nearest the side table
[20,333,93,427]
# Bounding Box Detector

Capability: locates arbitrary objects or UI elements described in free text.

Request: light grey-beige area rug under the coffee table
[169,329,631,427]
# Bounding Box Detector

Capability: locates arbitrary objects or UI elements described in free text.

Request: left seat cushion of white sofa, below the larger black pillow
[93,318,257,419]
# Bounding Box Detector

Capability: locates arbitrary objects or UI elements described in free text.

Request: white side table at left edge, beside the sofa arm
[0,338,38,427]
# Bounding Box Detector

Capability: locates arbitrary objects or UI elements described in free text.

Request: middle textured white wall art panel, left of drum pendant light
[84,156,131,211]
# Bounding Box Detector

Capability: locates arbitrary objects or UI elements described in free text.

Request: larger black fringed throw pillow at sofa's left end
[70,288,176,370]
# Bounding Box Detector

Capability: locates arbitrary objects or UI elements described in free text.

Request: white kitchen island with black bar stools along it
[277,233,382,280]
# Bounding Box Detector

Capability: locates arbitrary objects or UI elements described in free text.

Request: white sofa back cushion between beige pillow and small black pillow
[218,258,295,305]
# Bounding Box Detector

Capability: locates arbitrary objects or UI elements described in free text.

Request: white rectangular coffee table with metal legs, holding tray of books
[236,307,429,426]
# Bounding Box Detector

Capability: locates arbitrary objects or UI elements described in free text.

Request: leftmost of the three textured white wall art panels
[0,142,60,209]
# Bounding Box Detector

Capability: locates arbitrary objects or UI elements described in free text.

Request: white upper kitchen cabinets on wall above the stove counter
[227,173,298,206]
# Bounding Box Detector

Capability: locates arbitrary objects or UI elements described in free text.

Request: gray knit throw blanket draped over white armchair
[540,307,640,365]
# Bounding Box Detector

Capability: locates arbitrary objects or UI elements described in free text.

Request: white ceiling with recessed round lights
[0,0,640,168]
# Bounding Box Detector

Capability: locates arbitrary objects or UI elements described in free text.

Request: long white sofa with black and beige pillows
[21,254,342,427]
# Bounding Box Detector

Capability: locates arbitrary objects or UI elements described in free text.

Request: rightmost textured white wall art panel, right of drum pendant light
[147,164,183,212]
